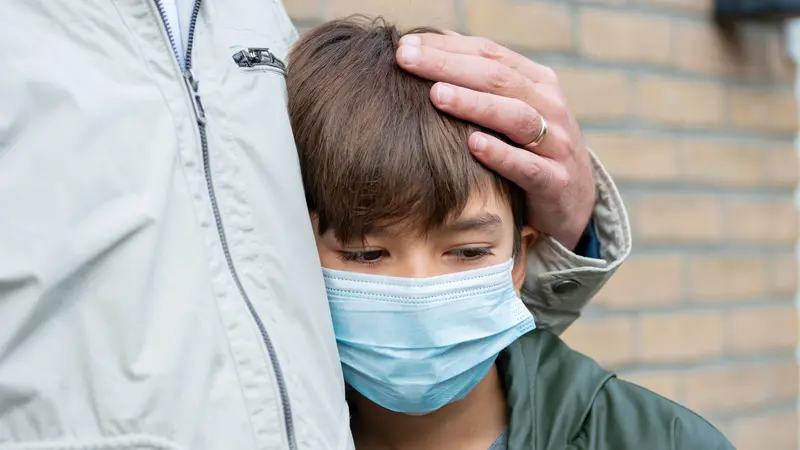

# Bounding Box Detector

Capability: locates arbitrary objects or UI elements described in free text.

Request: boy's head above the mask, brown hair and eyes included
[287,17,535,289]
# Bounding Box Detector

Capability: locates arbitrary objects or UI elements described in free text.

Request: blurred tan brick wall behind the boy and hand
[285,0,798,450]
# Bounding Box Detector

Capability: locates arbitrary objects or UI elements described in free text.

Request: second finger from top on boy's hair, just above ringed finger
[397,45,538,103]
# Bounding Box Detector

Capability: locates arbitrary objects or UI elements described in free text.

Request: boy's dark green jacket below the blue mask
[497,330,734,450]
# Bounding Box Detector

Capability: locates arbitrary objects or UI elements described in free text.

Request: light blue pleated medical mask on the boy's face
[323,260,536,415]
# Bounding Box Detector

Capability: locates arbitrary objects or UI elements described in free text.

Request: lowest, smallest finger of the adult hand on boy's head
[469,132,554,192]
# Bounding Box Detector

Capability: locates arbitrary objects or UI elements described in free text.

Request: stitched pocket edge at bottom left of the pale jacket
[0,434,184,450]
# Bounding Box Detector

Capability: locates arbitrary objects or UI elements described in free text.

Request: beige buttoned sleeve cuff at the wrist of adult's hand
[522,152,631,335]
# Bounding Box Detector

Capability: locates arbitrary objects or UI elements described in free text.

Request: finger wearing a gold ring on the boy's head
[431,83,542,146]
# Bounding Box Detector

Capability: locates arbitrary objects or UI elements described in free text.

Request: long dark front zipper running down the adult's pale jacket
[155,0,297,450]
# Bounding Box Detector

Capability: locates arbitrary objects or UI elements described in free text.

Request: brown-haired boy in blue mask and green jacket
[287,19,733,450]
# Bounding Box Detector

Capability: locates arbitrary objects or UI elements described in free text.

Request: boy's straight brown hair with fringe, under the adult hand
[287,16,524,250]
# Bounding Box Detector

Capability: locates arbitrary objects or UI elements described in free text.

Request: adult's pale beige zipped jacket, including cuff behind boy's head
[0,0,630,450]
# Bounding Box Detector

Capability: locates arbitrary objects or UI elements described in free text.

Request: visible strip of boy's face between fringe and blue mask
[314,189,534,290]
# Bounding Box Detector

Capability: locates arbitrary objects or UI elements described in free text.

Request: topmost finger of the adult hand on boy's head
[400,33,557,83]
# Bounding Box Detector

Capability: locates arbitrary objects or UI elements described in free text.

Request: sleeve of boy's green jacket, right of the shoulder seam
[569,378,735,450]
